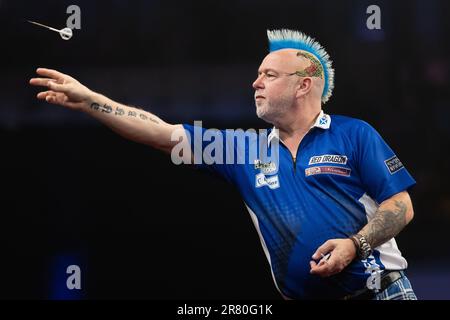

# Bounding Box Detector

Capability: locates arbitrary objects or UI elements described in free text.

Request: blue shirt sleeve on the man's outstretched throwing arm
[183,124,235,183]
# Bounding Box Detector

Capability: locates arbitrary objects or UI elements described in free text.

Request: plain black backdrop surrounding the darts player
[0,0,450,299]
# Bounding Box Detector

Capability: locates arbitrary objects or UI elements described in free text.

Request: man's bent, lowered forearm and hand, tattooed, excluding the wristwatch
[310,191,414,277]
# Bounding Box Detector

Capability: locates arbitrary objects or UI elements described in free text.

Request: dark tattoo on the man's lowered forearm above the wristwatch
[360,200,407,248]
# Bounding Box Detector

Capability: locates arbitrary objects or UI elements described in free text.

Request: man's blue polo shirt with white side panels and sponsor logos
[184,111,415,299]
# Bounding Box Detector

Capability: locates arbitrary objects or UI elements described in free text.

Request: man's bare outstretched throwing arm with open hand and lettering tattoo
[30,68,185,153]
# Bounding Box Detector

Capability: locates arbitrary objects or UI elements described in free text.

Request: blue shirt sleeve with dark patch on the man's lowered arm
[357,122,416,203]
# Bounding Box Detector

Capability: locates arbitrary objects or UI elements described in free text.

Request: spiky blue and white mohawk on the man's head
[267,29,334,103]
